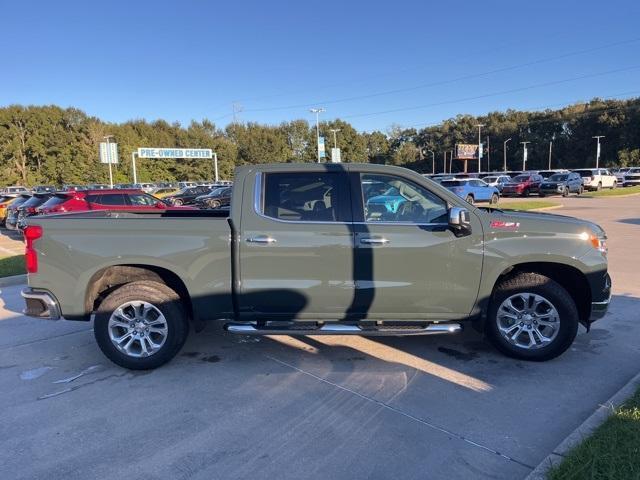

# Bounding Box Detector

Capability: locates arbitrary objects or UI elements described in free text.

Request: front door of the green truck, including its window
[351,173,483,320]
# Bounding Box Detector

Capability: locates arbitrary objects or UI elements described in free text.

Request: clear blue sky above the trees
[0,0,640,131]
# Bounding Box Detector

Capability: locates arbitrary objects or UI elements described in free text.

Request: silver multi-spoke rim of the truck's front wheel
[496,292,560,350]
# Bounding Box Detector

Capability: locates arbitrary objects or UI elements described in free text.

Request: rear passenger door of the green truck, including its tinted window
[238,165,355,320]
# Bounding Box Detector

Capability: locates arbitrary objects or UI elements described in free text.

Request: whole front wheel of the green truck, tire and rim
[485,273,579,361]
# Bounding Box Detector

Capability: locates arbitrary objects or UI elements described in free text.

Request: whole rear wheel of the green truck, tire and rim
[93,281,189,370]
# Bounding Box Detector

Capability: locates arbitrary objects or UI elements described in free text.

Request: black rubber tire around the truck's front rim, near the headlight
[485,273,579,362]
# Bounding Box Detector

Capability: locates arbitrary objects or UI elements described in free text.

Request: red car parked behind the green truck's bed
[38,189,193,215]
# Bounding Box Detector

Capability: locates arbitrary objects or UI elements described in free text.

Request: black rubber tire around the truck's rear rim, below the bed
[93,280,189,370]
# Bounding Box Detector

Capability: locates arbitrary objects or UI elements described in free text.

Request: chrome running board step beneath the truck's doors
[224,323,462,336]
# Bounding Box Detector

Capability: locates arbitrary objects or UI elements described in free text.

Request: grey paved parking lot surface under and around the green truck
[0,196,640,480]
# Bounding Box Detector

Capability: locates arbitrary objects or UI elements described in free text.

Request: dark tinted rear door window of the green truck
[259,172,349,222]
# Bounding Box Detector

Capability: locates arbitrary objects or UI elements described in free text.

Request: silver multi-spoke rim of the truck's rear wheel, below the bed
[108,301,169,358]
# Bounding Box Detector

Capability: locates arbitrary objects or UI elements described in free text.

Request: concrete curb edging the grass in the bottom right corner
[525,373,640,480]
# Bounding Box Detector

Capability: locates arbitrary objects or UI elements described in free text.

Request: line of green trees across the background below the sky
[0,98,640,185]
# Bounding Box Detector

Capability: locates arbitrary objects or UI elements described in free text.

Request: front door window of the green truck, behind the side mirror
[361,174,448,224]
